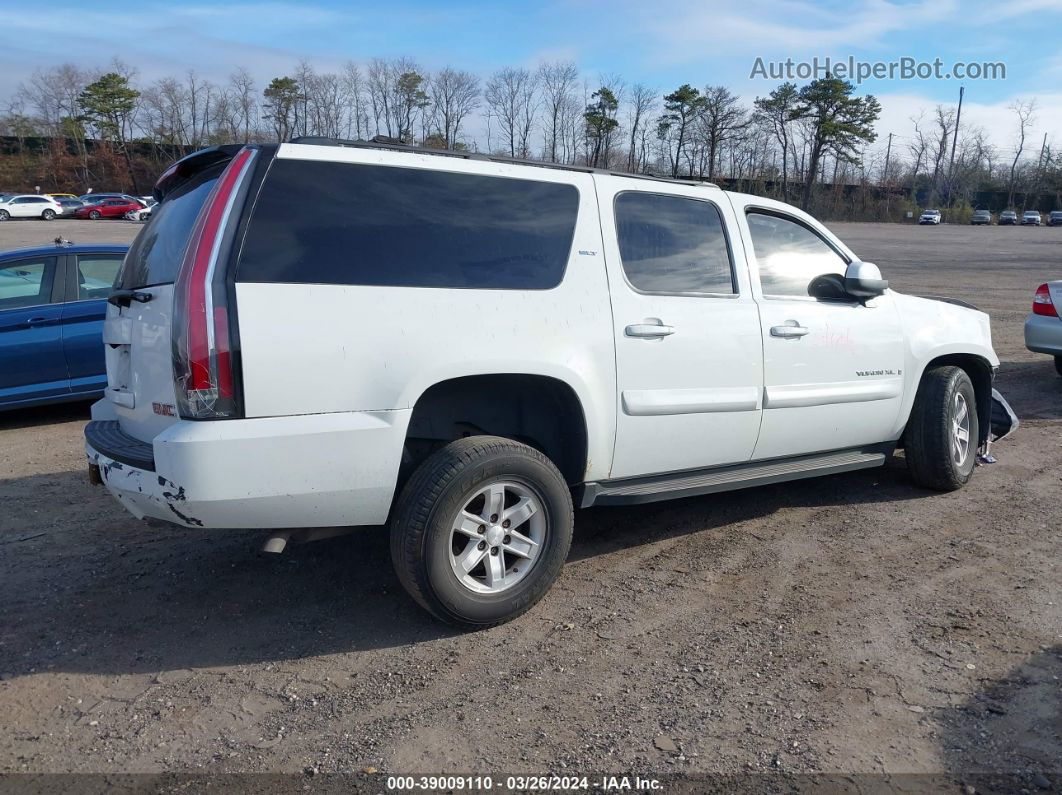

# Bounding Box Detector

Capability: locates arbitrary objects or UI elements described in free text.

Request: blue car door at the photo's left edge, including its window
[0,256,69,405]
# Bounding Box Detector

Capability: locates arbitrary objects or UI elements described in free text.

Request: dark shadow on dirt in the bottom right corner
[936,645,1062,793]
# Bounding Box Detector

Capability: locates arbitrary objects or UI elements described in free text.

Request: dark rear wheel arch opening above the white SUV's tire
[399,373,588,489]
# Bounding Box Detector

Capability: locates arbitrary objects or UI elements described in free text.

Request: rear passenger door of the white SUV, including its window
[595,176,763,479]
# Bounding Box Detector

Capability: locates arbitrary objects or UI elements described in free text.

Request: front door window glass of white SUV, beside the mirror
[748,212,847,296]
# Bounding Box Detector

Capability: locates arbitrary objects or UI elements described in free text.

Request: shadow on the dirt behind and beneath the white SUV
[0,464,931,676]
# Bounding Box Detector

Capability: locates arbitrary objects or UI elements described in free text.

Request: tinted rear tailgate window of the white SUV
[115,162,227,290]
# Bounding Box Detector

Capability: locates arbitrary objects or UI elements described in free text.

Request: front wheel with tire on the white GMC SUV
[906,366,979,491]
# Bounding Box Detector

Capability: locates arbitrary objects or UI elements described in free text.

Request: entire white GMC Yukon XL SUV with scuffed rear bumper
[85,139,1011,627]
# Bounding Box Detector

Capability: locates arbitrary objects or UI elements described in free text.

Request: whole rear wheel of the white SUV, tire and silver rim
[391,436,575,629]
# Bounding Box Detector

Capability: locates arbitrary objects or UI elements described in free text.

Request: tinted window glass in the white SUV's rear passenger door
[616,193,736,293]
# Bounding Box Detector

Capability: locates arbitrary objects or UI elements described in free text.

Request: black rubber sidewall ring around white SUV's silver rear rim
[422,453,571,624]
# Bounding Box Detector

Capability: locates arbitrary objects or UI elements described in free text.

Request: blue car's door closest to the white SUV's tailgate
[63,253,123,393]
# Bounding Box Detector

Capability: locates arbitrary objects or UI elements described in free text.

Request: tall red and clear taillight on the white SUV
[173,149,255,419]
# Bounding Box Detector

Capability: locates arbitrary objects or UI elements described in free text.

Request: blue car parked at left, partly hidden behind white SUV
[0,245,129,410]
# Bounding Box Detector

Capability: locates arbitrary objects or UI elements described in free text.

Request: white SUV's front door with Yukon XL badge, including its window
[734,196,904,460]
